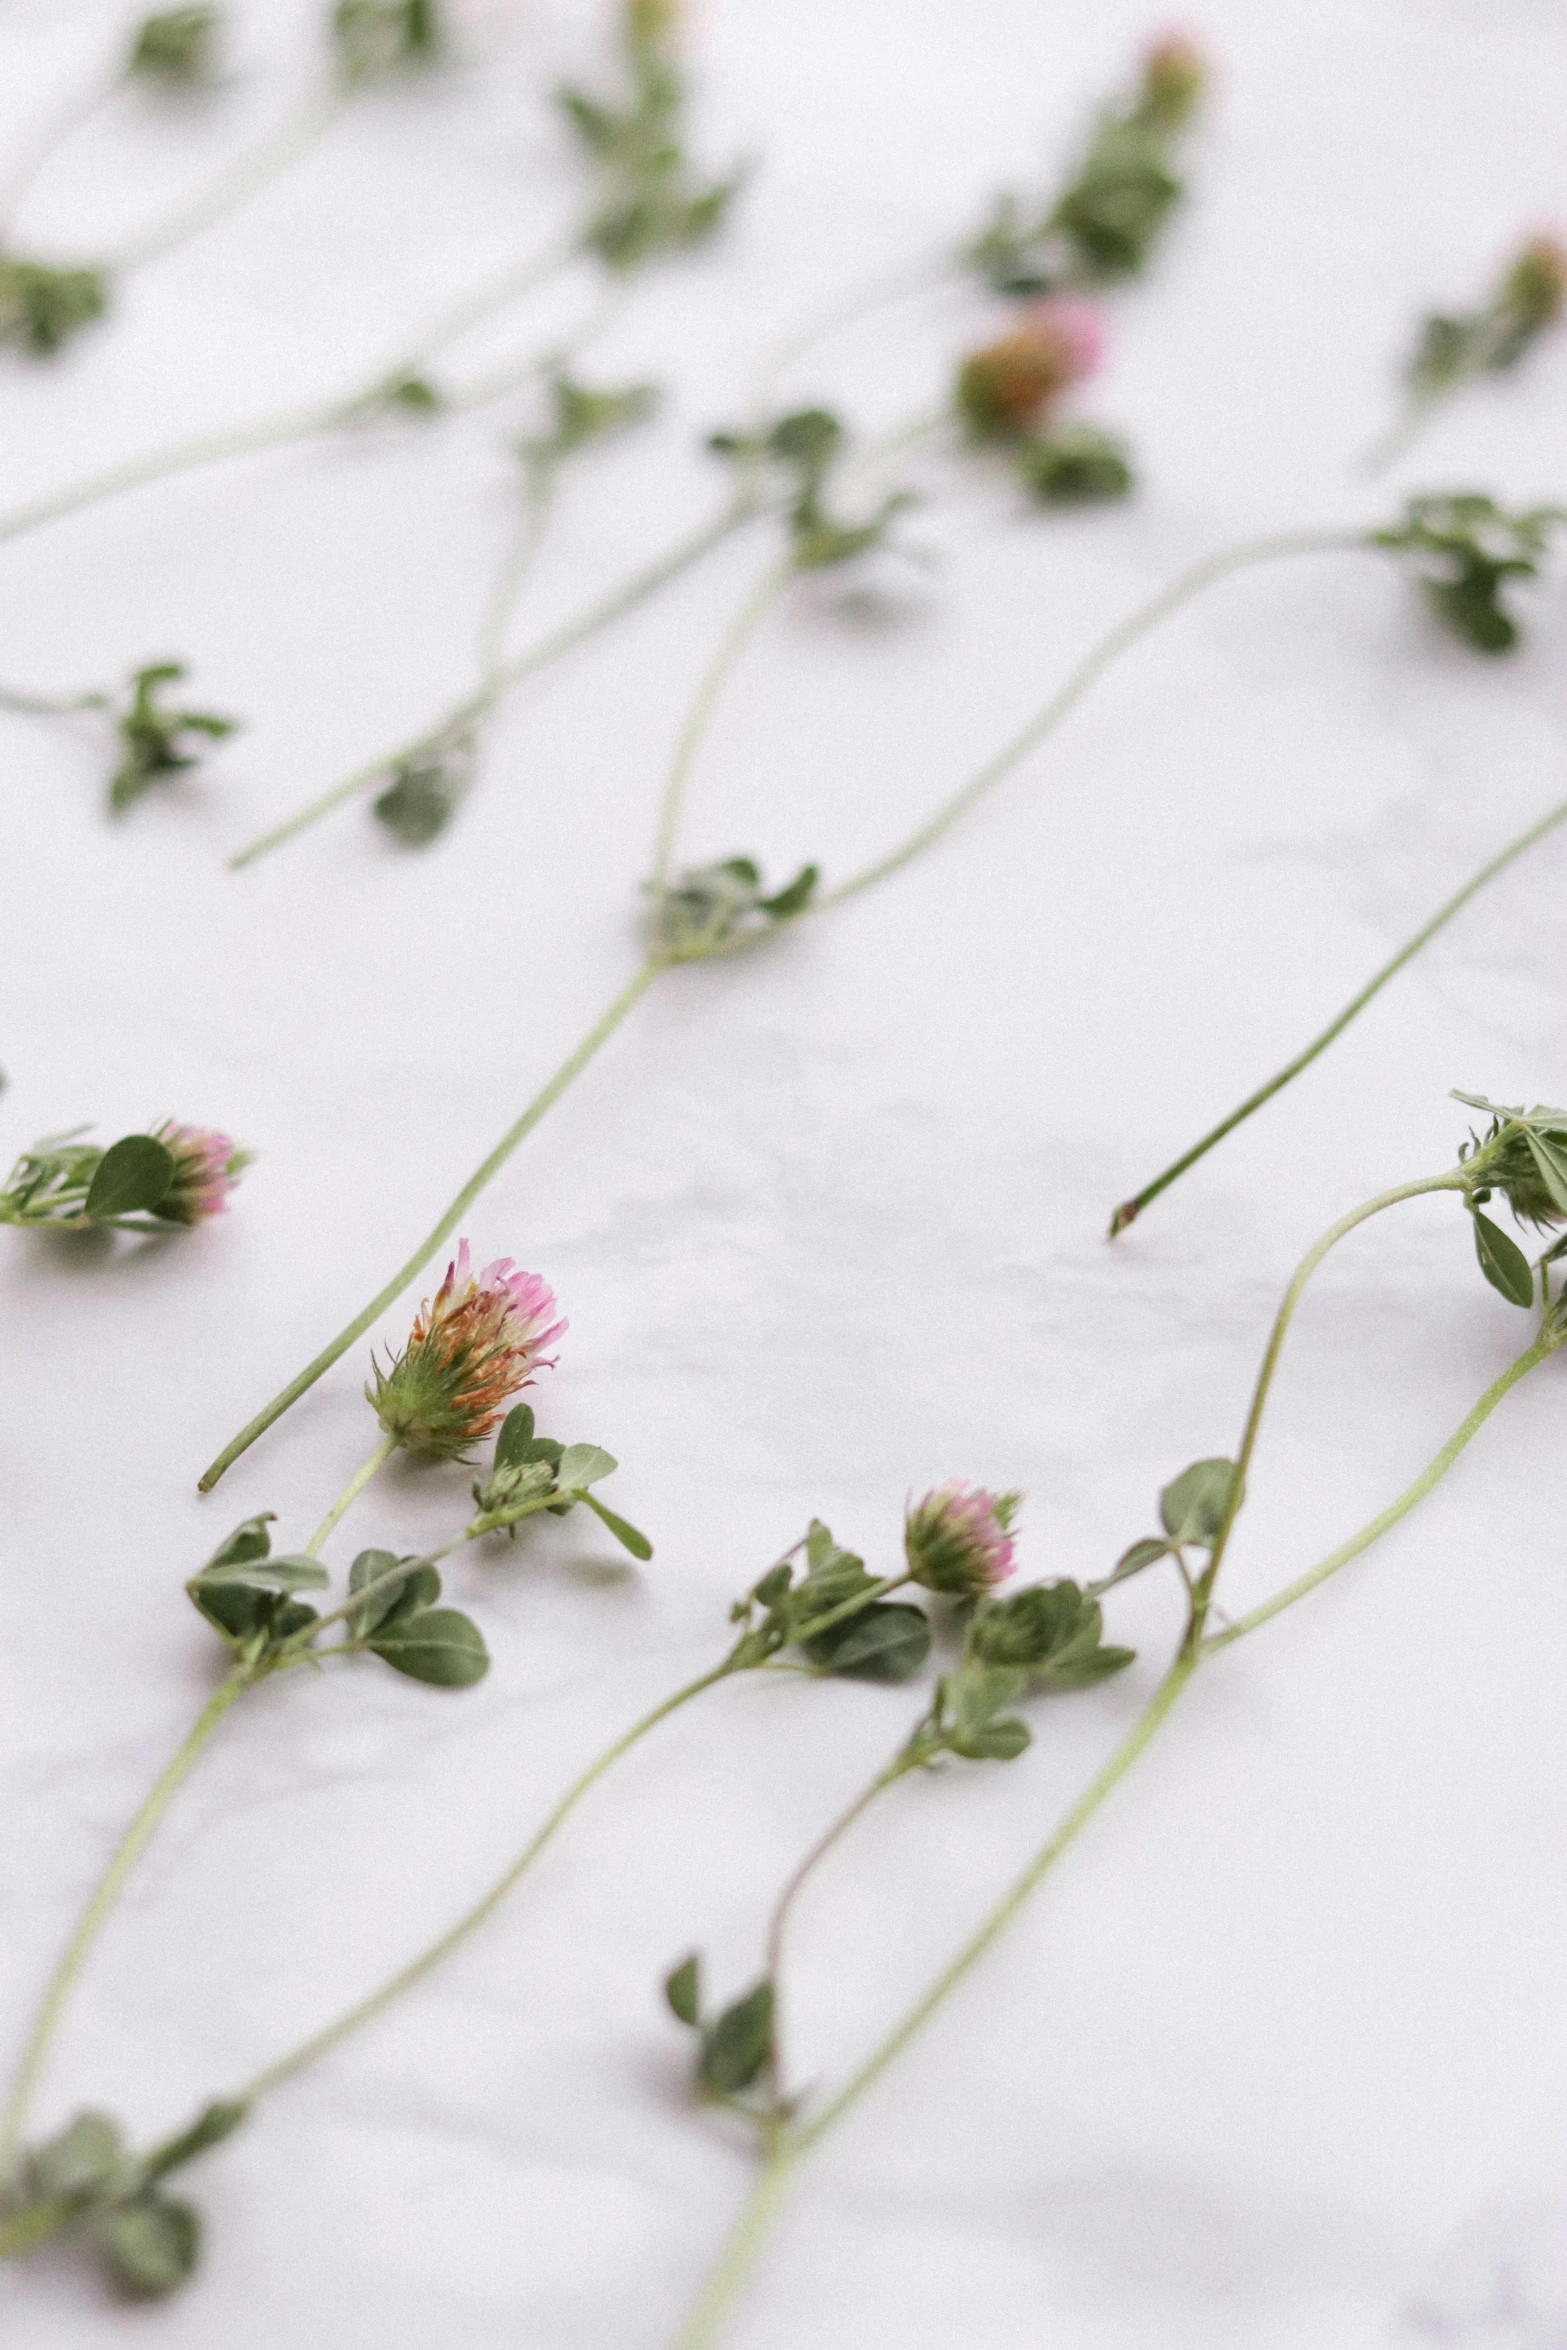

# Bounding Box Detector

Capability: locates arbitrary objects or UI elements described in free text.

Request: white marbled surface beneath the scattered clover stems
[0,0,1567,2350]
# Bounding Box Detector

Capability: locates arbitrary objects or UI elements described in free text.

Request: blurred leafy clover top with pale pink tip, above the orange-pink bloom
[968,40,1203,294]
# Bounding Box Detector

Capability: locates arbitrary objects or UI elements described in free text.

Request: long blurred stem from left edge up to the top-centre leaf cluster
[0,240,576,554]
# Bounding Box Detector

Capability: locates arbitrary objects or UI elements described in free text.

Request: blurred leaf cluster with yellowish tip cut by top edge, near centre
[557,0,740,270]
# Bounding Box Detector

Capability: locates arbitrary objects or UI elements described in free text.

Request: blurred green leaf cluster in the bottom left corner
[0,2101,247,2301]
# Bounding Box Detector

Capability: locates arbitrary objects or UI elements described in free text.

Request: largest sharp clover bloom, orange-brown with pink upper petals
[364,1241,566,1459]
